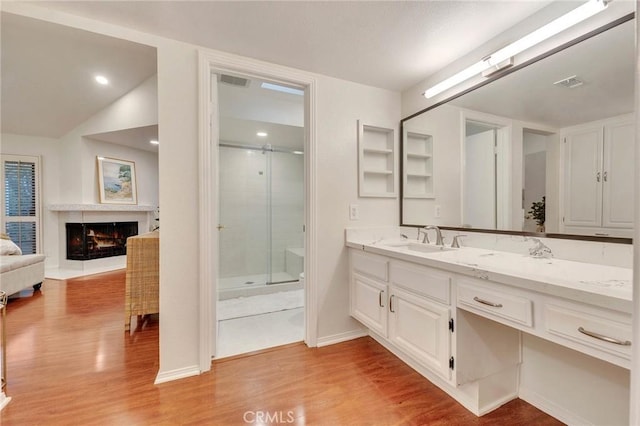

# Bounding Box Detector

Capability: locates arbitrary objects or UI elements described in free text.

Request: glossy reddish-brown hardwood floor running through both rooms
[0,272,559,426]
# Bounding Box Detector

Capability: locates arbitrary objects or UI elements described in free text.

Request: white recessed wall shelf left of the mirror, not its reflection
[358,121,397,198]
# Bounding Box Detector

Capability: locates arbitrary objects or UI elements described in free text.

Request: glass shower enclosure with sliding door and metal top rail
[218,142,304,299]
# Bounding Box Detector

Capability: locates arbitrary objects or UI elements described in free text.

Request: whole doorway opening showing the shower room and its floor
[215,73,305,358]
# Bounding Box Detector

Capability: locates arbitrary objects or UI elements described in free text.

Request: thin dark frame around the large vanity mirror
[398,12,635,244]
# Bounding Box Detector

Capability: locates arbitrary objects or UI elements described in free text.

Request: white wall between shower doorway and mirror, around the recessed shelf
[316,76,400,341]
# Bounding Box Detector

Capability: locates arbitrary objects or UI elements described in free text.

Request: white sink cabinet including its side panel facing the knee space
[349,248,521,415]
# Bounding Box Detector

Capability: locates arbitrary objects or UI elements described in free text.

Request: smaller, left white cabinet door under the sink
[351,273,387,337]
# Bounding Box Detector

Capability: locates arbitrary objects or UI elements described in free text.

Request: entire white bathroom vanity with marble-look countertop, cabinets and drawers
[346,230,632,424]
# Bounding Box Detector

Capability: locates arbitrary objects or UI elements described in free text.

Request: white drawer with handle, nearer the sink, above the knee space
[457,278,533,327]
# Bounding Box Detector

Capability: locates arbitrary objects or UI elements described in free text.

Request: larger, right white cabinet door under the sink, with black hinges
[389,287,451,380]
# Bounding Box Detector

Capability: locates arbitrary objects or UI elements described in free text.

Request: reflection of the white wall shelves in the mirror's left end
[402,130,434,198]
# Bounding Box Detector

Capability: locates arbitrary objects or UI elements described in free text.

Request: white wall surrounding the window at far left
[0,134,60,267]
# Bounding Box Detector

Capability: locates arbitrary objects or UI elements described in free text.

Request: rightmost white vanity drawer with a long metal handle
[545,303,631,360]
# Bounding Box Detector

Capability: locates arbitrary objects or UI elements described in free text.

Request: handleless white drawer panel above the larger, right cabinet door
[389,261,451,305]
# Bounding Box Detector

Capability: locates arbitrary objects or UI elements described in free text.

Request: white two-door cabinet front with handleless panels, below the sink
[350,250,452,380]
